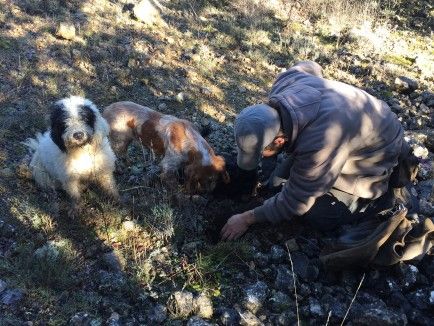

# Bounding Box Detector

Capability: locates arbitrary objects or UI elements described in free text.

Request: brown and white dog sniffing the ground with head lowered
[103,101,229,193]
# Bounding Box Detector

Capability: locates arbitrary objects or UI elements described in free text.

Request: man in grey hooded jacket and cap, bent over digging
[221,61,408,240]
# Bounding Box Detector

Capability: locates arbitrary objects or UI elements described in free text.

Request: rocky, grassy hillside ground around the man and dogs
[0,0,434,326]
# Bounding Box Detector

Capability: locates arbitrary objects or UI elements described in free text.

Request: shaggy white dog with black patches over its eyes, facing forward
[25,96,118,205]
